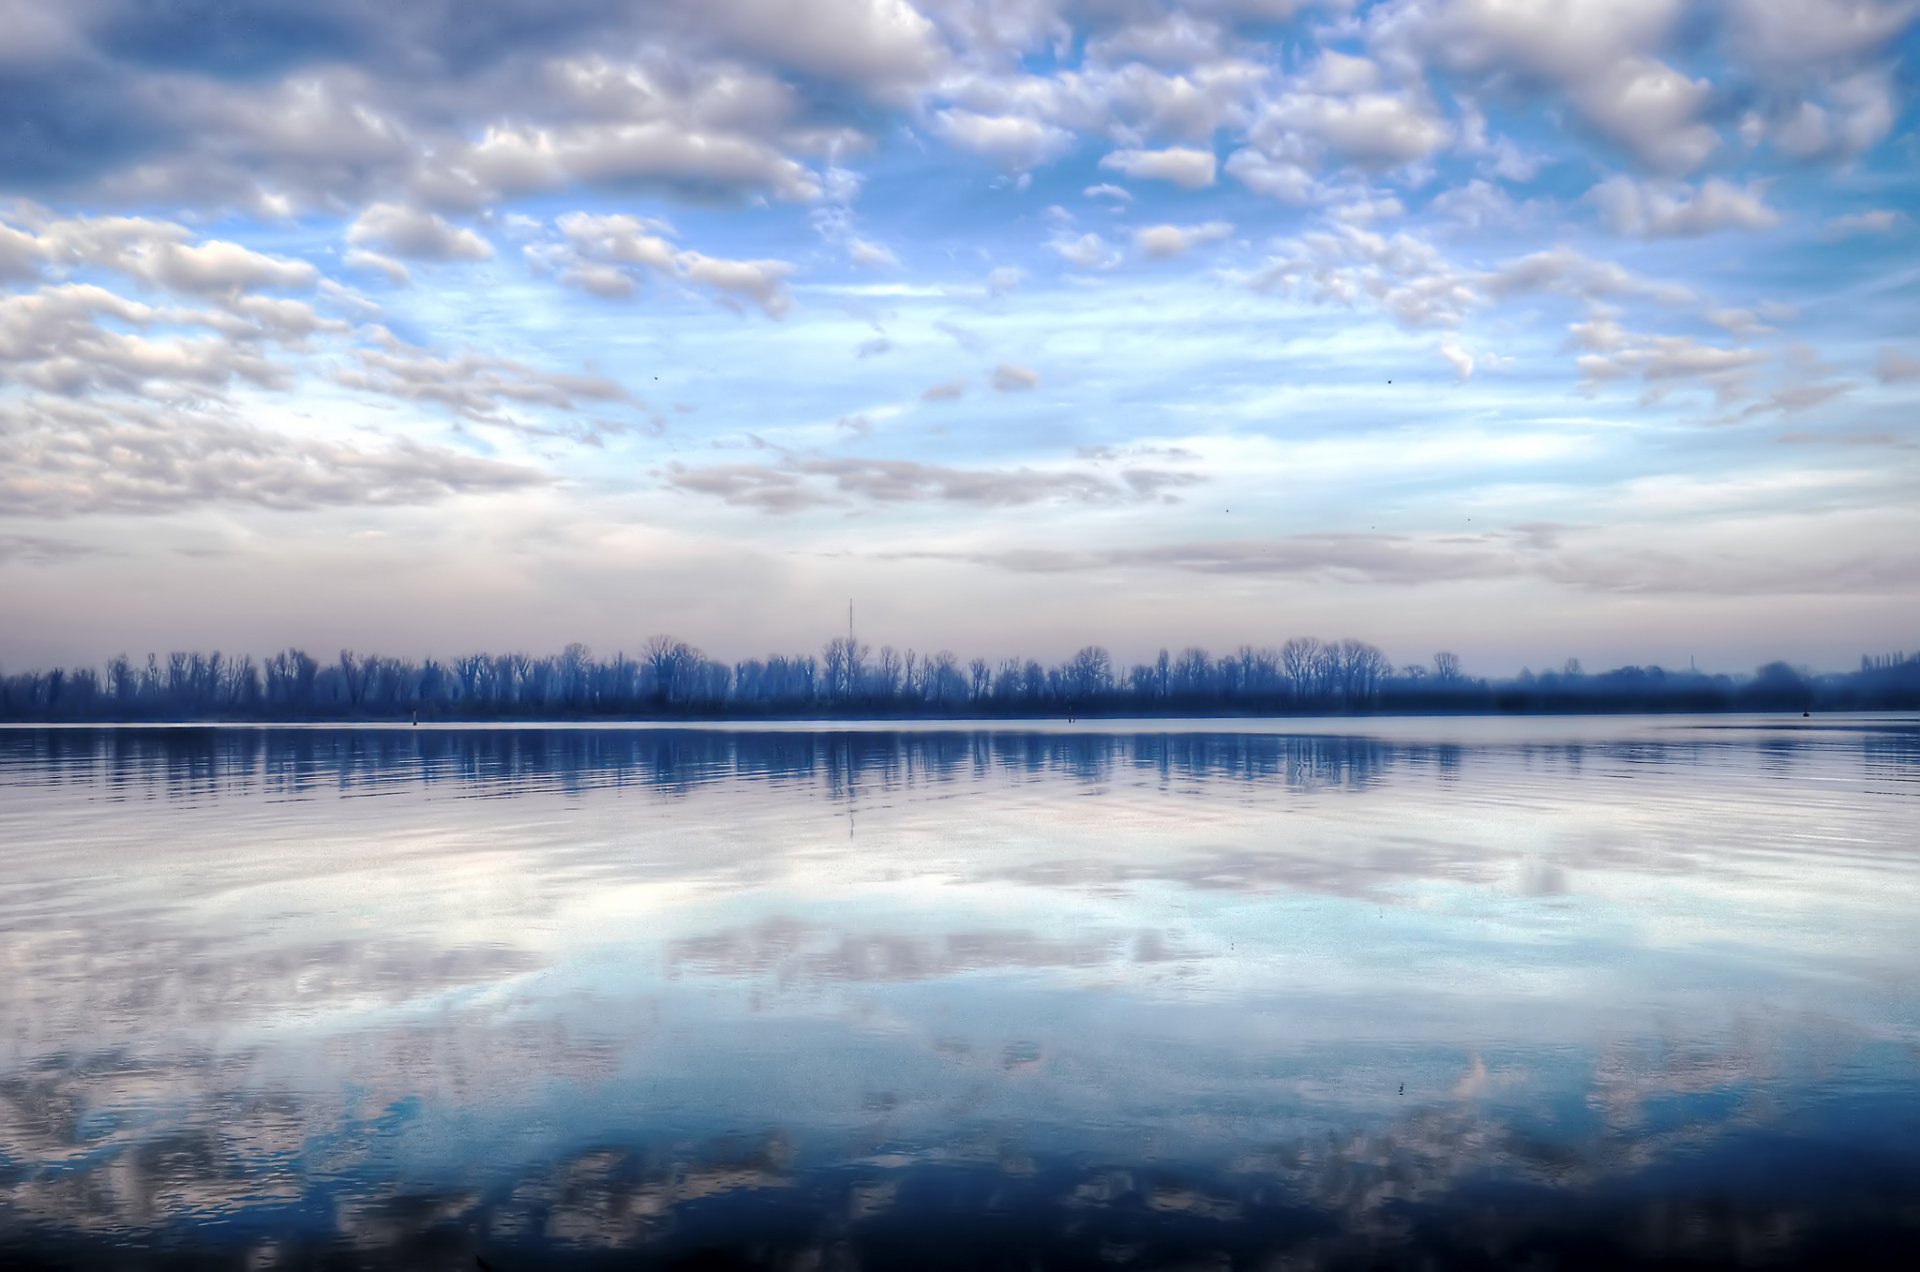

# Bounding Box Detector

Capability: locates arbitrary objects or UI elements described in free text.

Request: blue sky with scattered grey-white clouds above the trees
[0,0,1920,674]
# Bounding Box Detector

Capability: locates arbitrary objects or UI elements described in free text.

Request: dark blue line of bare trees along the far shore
[0,636,1920,721]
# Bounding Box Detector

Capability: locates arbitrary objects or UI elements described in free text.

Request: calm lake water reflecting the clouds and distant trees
[0,719,1920,1272]
